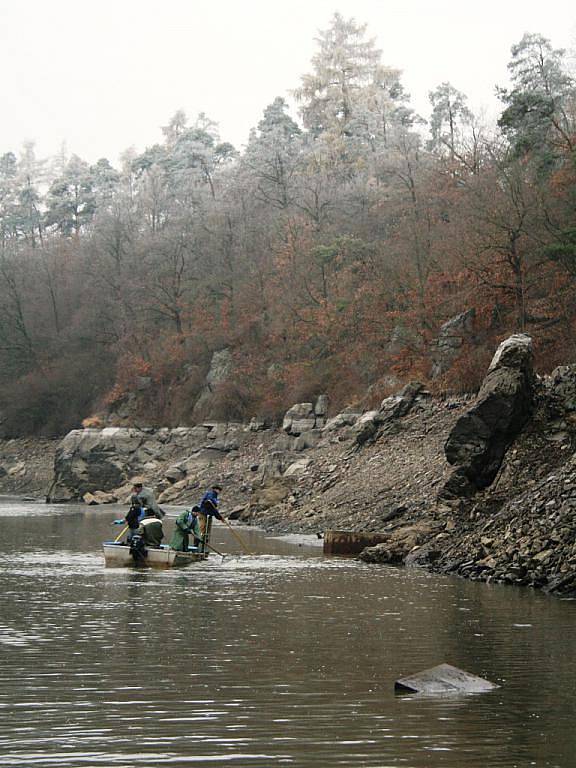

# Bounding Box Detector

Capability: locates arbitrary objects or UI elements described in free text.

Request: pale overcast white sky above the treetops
[0,0,576,163]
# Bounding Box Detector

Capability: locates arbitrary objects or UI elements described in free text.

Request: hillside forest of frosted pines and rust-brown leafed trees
[0,15,576,436]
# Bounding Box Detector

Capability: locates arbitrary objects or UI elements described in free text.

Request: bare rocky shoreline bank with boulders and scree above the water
[0,337,576,595]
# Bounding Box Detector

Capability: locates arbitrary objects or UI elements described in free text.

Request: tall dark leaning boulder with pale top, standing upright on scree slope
[441,334,535,497]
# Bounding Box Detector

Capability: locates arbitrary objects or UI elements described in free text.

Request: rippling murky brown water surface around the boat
[0,501,576,768]
